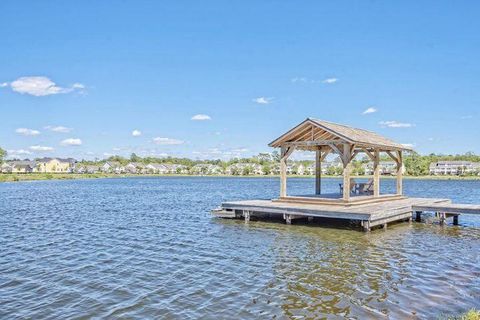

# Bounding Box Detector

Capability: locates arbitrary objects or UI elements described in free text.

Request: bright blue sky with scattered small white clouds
[0,1,480,159]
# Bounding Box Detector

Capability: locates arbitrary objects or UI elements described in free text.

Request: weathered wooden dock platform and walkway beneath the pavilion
[212,198,480,231]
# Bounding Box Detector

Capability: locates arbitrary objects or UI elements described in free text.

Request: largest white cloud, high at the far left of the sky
[2,76,85,97]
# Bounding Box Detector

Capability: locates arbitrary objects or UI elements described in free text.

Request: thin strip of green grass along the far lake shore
[0,173,480,182]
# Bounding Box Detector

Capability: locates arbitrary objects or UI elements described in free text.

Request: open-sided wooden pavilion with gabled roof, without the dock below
[269,118,412,203]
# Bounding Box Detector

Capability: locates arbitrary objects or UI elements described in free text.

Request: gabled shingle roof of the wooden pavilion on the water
[269,118,412,151]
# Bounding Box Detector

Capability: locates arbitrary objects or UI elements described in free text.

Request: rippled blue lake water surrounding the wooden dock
[0,178,480,319]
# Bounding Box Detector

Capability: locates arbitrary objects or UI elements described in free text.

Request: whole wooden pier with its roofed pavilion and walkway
[212,118,480,231]
